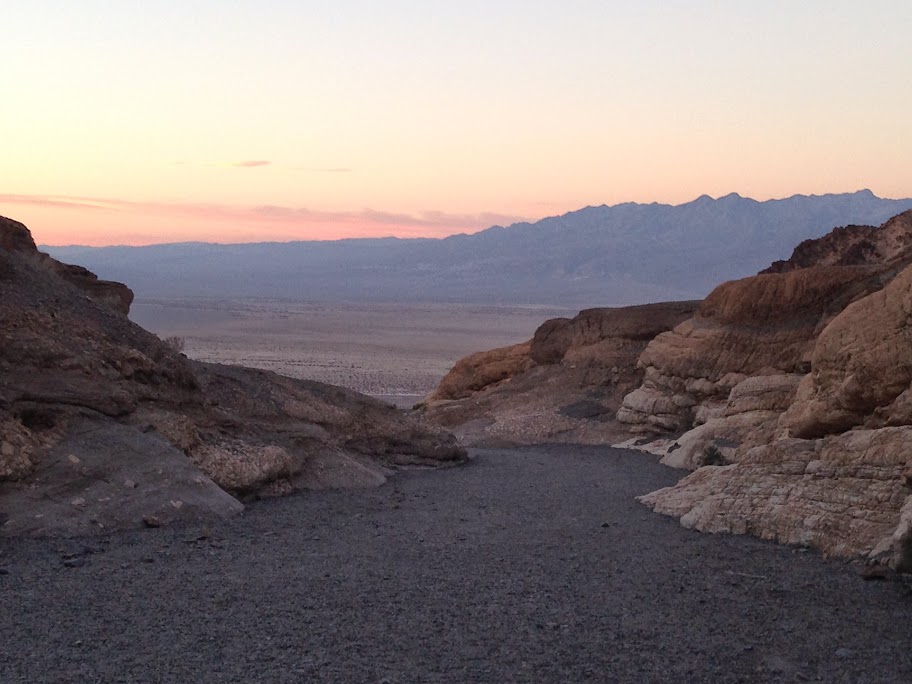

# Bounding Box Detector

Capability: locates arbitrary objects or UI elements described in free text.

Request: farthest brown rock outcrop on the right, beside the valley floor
[425,302,697,445]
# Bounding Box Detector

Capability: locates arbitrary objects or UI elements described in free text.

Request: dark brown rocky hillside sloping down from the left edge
[0,219,465,535]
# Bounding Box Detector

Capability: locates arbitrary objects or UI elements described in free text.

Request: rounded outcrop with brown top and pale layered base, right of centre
[617,266,888,432]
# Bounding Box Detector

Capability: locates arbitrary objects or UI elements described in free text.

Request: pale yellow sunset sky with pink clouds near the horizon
[0,0,912,245]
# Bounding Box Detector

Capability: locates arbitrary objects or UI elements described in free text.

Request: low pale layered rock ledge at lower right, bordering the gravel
[640,427,912,565]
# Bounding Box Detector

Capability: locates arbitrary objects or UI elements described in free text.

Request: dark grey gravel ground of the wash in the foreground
[0,447,912,684]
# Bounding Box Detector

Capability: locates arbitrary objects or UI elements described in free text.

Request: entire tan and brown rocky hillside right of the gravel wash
[428,212,912,571]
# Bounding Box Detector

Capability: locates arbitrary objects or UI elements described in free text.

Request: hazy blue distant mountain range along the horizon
[42,190,912,307]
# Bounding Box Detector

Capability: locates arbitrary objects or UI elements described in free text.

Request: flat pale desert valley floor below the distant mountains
[130,299,577,406]
